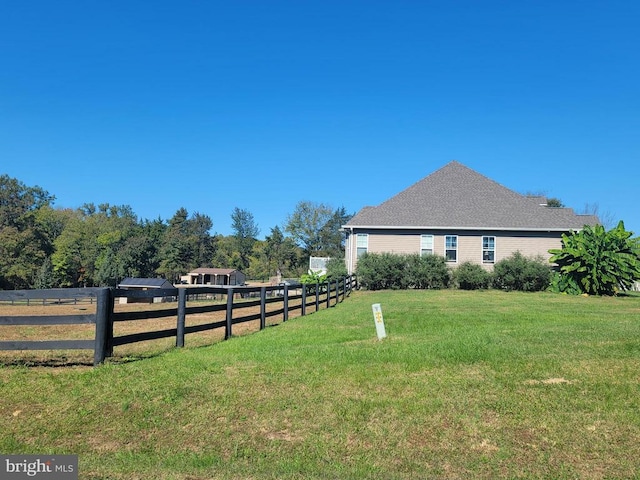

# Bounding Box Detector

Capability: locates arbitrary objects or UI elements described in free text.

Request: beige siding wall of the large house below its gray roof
[346,230,562,272]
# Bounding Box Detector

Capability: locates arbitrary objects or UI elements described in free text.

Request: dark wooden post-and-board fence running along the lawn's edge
[0,276,357,365]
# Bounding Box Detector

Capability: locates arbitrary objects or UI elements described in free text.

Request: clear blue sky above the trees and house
[0,0,640,237]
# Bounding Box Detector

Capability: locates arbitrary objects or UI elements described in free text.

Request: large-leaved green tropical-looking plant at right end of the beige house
[549,221,640,295]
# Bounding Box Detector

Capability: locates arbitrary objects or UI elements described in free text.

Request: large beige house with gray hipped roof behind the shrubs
[342,161,599,273]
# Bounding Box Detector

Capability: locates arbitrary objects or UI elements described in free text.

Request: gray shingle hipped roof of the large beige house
[345,161,599,231]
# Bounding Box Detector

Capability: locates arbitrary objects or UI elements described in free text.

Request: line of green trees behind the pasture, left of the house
[0,175,352,290]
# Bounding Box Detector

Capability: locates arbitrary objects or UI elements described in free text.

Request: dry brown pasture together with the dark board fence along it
[0,277,356,365]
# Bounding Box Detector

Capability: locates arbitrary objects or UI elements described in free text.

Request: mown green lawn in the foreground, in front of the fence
[0,290,640,480]
